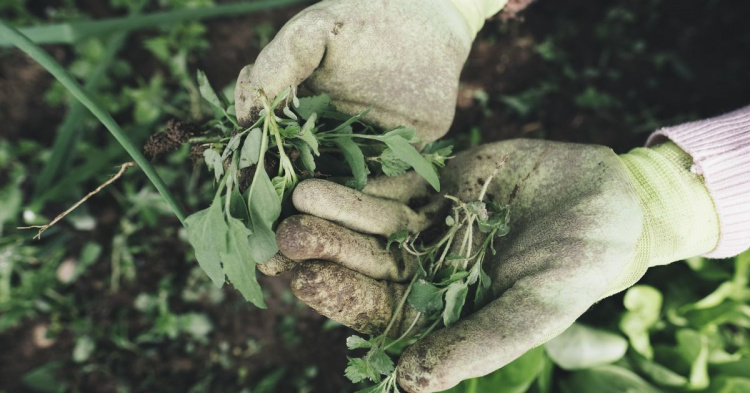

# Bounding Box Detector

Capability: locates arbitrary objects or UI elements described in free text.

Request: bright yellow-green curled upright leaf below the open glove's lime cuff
[620,285,662,359]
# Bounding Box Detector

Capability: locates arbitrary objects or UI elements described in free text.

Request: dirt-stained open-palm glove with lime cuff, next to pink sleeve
[277,140,719,392]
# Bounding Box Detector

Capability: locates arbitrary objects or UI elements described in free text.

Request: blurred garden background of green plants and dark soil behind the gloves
[0,0,750,393]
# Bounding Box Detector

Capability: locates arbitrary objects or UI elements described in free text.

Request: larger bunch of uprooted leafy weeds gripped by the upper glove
[186,71,452,307]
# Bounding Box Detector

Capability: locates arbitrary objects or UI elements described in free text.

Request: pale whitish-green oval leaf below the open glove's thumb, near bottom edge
[545,323,628,370]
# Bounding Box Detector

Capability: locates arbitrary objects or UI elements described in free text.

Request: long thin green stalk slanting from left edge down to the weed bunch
[0,20,185,225]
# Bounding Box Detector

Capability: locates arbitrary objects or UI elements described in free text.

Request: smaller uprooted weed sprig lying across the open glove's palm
[345,167,510,393]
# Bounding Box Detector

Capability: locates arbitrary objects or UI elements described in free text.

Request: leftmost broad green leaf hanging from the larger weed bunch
[185,196,228,288]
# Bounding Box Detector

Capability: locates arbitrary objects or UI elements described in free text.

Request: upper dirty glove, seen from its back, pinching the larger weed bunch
[235,0,505,143]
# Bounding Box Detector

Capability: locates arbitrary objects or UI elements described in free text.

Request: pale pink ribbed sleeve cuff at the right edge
[647,106,750,258]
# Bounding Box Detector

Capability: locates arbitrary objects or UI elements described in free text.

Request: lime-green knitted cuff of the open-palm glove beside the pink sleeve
[604,142,719,297]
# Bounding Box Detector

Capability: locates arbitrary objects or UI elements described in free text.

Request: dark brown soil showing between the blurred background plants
[0,0,750,393]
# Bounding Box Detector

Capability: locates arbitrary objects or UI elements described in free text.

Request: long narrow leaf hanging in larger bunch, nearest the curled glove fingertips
[247,169,281,263]
